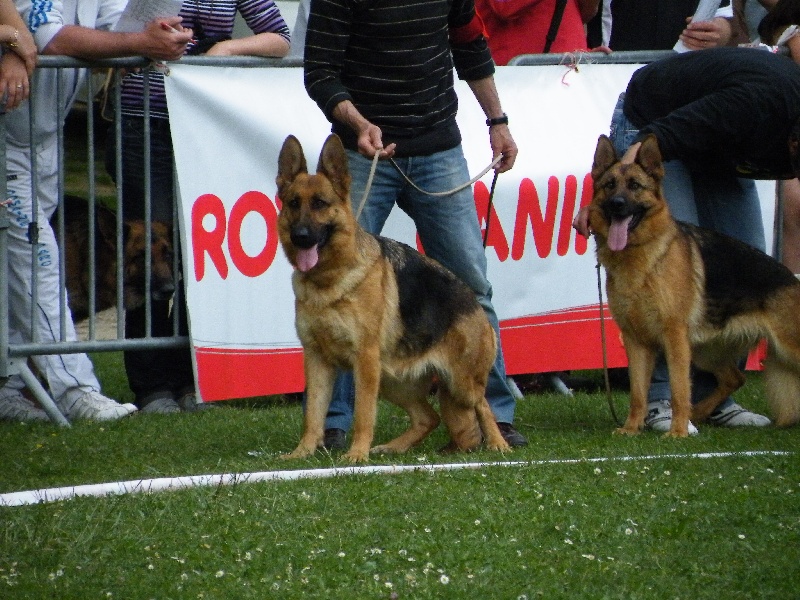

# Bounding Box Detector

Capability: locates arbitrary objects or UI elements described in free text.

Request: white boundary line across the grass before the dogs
[0,450,794,506]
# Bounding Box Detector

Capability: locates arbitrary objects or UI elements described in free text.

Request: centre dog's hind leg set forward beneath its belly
[370,376,439,454]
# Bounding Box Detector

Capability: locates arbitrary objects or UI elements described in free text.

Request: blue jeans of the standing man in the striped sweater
[325,146,516,431]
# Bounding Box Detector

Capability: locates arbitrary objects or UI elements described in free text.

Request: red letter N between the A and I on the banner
[511,176,558,260]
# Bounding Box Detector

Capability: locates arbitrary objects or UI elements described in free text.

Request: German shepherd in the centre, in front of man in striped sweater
[276,135,509,462]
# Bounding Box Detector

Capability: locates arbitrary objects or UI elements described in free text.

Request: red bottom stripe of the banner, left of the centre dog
[195,347,305,402]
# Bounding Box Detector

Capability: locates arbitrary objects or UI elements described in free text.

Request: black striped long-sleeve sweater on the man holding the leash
[305,0,494,156]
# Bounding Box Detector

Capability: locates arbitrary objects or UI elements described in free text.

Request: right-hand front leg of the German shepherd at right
[664,326,692,437]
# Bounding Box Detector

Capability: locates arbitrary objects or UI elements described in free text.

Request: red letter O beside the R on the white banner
[228,192,278,277]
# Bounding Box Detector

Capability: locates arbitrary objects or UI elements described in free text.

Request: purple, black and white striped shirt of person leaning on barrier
[122,0,290,119]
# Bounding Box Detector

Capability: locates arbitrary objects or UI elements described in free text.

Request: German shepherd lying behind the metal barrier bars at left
[51,195,175,321]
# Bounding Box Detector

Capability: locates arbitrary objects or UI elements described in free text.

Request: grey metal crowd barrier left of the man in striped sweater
[0,56,302,427]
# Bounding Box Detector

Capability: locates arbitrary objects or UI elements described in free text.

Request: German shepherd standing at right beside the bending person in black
[589,135,800,437]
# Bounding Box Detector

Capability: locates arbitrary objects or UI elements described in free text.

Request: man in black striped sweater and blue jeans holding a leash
[304,0,527,449]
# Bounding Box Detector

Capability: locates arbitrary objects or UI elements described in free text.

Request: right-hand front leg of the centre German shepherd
[344,344,381,463]
